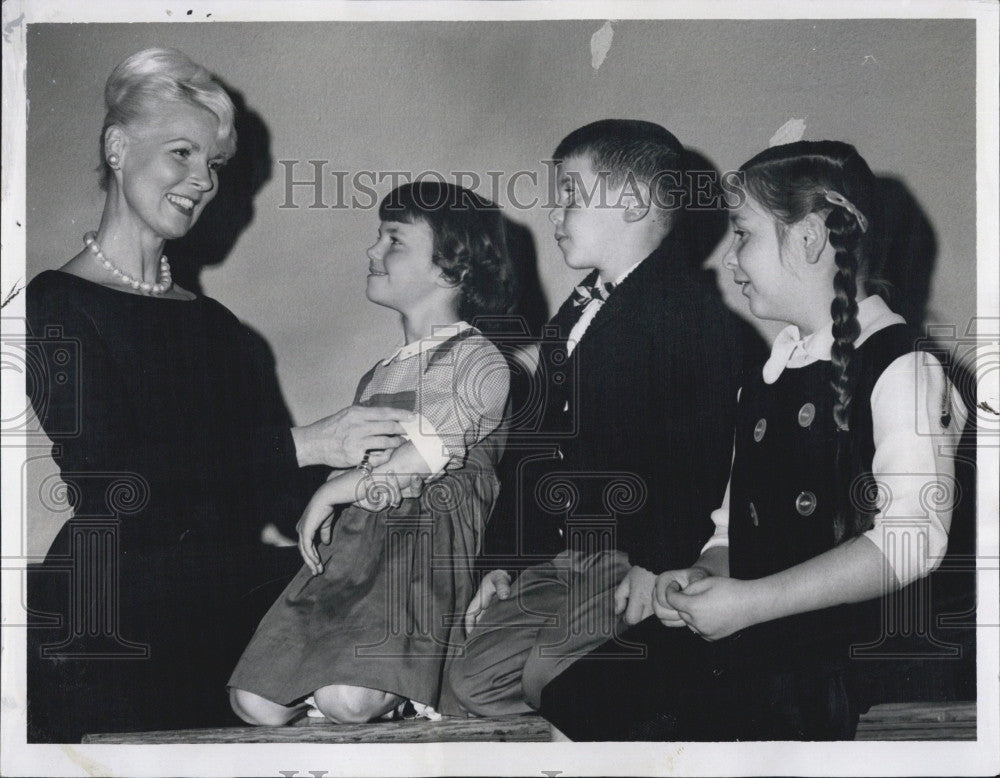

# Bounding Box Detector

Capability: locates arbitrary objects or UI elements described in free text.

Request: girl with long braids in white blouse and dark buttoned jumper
[541,141,963,740]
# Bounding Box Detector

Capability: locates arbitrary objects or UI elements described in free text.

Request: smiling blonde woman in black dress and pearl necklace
[27,49,407,742]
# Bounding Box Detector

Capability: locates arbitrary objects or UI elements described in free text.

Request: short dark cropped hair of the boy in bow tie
[553,119,684,220]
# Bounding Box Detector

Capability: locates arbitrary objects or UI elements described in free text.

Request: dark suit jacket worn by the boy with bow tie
[479,230,747,573]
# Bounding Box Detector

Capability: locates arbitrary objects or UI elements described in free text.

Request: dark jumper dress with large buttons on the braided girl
[541,325,914,740]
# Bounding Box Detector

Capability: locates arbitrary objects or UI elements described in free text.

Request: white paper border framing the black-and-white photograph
[0,0,1000,776]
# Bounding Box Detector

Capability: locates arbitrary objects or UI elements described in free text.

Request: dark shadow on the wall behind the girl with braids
[857,177,981,704]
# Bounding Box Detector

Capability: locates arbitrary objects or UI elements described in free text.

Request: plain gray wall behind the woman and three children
[27,20,976,553]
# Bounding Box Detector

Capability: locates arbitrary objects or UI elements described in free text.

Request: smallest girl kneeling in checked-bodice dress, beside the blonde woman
[229,182,514,725]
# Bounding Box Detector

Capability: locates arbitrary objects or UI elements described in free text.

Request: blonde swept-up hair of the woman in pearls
[98,48,236,191]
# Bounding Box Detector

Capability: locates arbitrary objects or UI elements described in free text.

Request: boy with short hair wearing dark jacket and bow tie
[449,120,745,716]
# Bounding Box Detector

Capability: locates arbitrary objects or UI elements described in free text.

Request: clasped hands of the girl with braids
[666,576,758,640]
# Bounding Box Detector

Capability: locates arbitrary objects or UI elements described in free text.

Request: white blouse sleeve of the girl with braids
[864,352,965,586]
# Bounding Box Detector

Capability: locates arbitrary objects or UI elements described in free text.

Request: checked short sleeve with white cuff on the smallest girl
[403,328,510,474]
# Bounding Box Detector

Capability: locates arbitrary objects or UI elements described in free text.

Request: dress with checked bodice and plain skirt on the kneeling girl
[229,328,509,713]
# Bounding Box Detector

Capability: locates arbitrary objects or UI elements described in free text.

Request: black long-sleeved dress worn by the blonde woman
[27,271,308,742]
